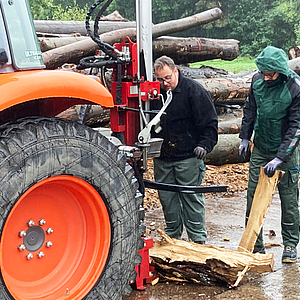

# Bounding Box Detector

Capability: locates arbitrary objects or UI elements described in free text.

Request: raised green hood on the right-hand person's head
[255,46,291,76]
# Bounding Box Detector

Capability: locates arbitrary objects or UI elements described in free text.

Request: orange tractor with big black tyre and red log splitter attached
[0,0,225,300]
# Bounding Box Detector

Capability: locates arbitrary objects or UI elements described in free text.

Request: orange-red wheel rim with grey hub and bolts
[0,176,111,300]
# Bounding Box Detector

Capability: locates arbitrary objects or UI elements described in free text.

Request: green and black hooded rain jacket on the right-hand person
[240,46,300,161]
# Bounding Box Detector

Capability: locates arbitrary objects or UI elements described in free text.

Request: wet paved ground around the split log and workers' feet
[123,192,300,300]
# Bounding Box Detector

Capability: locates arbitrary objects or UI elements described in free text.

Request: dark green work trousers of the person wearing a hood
[246,146,299,247]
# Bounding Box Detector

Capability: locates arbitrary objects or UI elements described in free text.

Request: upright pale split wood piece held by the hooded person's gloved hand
[238,167,282,253]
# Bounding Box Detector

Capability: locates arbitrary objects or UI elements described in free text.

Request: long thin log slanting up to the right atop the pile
[42,8,222,69]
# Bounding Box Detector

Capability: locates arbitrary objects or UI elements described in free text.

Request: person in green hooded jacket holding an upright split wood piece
[239,46,300,262]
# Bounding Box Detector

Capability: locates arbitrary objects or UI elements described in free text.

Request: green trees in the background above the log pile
[30,0,300,57]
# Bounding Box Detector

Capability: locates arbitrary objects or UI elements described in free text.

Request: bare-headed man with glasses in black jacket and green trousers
[151,56,218,243]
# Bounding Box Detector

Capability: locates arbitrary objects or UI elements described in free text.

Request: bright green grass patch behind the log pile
[190,56,257,73]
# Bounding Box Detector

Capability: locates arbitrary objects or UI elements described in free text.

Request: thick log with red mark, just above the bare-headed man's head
[153,36,239,64]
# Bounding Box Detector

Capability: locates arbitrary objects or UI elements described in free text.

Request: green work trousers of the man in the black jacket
[154,157,207,242]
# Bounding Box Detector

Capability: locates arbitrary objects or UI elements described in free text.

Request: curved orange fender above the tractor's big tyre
[0,70,113,111]
